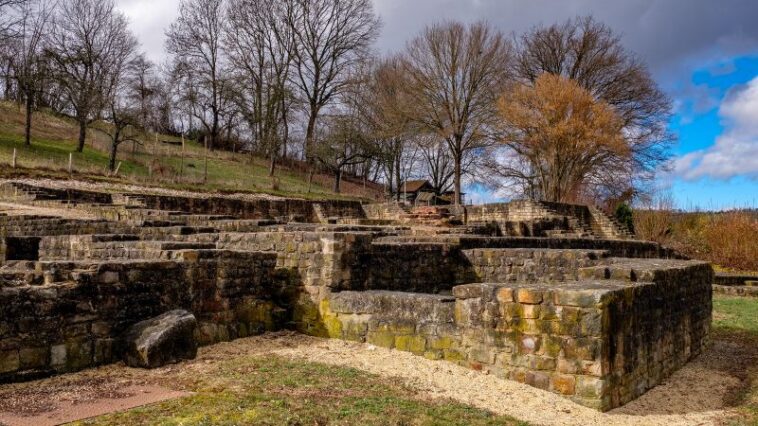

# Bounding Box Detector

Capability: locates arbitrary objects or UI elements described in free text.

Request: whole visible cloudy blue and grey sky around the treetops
[116,0,758,210]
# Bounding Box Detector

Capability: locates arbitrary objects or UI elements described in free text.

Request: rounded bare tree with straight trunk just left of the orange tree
[403,22,511,204]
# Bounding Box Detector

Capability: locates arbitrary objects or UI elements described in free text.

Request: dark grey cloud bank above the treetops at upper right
[375,0,758,85]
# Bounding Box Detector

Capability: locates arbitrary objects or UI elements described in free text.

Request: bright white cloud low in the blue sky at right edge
[675,77,758,180]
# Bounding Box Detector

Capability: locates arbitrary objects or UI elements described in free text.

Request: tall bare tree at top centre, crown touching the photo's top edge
[287,0,380,159]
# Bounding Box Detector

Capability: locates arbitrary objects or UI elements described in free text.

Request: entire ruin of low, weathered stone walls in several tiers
[0,182,713,410]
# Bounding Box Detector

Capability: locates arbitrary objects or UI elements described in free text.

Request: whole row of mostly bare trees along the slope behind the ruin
[0,0,673,203]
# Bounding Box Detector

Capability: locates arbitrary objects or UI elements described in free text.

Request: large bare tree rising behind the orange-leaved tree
[514,17,673,201]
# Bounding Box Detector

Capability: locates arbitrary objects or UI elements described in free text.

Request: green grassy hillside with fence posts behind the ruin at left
[0,103,379,199]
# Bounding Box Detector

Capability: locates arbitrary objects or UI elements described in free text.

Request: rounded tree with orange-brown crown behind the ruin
[495,73,631,202]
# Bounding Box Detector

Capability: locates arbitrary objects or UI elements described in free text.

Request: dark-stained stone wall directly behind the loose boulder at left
[0,250,284,381]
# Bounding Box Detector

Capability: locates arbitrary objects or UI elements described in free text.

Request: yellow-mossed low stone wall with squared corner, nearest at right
[320,261,712,410]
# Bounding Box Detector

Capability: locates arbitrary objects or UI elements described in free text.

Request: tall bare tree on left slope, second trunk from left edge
[47,0,128,152]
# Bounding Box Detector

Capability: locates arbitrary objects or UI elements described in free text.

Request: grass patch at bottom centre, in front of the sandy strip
[80,356,525,425]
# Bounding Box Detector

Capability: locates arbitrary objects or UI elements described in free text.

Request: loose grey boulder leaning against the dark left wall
[122,310,197,368]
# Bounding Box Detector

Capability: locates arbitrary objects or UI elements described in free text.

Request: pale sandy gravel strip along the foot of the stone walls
[0,332,756,426]
